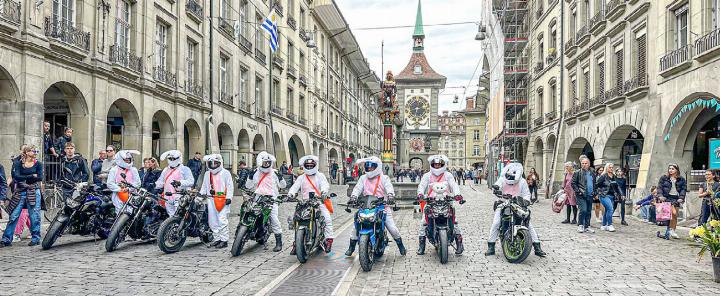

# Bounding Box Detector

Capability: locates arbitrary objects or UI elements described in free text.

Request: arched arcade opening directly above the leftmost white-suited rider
[105,99,142,150]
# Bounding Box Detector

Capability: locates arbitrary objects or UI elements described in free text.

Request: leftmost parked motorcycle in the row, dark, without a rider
[42,180,115,250]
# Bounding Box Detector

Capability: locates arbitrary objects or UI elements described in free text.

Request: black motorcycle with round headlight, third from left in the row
[157,189,213,254]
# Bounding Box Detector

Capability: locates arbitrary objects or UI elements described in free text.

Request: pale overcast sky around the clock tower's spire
[335,0,482,112]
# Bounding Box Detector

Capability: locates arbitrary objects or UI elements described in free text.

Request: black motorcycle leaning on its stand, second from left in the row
[105,174,169,252]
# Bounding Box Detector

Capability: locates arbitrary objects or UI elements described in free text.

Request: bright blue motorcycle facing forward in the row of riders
[345,195,388,272]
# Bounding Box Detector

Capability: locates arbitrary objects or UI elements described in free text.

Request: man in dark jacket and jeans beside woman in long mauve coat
[571,156,597,233]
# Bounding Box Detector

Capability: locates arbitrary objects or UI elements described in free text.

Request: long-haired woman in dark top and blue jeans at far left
[0,144,43,247]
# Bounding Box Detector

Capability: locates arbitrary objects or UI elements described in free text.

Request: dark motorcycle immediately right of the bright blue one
[423,194,465,264]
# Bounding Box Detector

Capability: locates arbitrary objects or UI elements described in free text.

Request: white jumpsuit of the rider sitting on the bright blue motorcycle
[350,175,401,241]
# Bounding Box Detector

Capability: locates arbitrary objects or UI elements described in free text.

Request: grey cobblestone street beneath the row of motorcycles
[0,185,720,295]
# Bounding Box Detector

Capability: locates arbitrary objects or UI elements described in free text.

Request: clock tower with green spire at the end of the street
[395,0,447,168]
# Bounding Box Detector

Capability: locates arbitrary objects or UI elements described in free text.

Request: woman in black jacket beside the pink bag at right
[657,163,687,239]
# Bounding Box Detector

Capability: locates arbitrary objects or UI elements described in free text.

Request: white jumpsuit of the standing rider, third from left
[200,168,235,242]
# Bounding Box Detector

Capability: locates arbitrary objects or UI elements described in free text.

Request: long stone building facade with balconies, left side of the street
[0,0,381,175]
